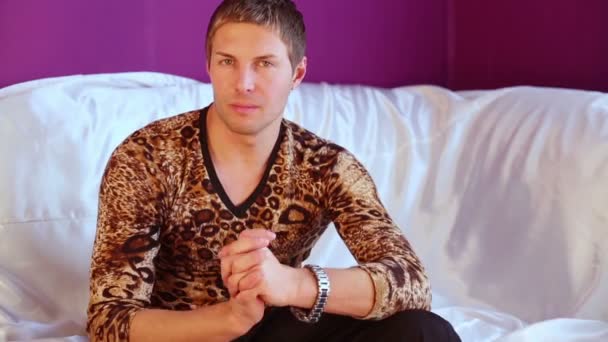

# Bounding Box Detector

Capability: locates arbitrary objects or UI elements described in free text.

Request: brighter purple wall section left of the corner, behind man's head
[0,0,447,87]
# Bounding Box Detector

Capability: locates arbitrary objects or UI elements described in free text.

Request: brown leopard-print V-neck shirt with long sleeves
[87,107,431,341]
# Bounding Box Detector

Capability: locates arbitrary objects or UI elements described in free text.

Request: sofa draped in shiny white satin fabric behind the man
[0,73,608,342]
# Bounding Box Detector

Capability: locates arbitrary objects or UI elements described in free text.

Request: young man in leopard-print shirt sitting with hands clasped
[87,0,459,341]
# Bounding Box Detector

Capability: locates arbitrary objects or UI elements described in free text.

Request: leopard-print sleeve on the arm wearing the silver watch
[326,151,431,319]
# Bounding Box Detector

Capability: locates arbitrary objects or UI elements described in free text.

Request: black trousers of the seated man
[235,308,460,342]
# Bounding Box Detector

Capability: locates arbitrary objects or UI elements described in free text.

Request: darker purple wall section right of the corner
[448,0,608,92]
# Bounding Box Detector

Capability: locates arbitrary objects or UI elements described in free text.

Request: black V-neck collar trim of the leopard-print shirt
[199,105,285,218]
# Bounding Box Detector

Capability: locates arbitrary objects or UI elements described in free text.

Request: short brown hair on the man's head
[206,0,306,69]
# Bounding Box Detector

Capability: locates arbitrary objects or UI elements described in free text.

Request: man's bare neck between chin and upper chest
[206,105,281,168]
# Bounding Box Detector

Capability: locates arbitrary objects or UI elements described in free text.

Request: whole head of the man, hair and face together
[207,0,306,137]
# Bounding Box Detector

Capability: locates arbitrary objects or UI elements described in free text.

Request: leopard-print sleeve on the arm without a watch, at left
[87,137,162,341]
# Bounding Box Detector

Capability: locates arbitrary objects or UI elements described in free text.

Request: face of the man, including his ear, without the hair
[207,23,306,135]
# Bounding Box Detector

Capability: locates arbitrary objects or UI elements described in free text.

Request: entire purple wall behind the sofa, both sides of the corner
[0,0,608,91]
